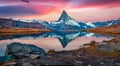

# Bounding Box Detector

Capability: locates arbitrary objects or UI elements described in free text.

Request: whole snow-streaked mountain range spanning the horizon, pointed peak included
[0,11,120,31]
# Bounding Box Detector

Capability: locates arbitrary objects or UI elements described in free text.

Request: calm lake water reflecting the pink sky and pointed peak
[0,32,112,56]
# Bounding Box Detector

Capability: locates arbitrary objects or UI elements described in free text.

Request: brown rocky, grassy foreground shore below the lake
[1,37,120,66]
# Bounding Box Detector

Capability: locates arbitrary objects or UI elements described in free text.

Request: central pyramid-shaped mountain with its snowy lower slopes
[43,11,83,31]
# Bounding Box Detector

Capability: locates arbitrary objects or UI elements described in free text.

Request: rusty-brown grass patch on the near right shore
[77,44,120,57]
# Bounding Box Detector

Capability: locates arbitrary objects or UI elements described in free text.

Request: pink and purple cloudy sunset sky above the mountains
[0,0,120,22]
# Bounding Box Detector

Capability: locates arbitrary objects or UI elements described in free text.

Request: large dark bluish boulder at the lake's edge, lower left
[6,42,45,58]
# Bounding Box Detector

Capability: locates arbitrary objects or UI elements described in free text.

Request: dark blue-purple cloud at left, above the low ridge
[0,6,37,16]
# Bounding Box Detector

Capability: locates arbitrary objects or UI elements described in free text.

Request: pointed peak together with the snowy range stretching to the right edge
[44,10,120,31]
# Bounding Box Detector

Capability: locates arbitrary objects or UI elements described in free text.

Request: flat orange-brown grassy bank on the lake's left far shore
[0,28,51,36]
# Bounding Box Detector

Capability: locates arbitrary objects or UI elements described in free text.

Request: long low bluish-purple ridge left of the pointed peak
[0,18,46,29]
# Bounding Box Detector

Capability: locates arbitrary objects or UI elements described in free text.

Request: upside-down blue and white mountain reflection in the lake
[27,32,111,48]
